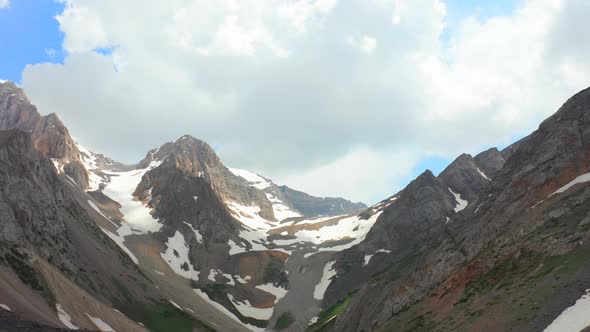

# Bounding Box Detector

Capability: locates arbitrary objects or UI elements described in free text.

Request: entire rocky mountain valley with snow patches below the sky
[0,81,590,332]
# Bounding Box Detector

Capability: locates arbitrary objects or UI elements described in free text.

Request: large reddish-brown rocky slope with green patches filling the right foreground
[322,90,590,331]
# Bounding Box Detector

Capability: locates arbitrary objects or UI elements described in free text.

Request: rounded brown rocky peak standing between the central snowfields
[134,136,251,279]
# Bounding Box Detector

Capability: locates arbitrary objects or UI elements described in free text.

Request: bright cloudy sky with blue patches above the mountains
[0,0,590,203]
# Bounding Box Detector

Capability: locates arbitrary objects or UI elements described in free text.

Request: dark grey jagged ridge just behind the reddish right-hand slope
[325,149,504,305]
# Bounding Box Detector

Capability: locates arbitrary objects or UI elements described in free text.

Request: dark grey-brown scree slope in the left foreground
[0,129,164,331]
